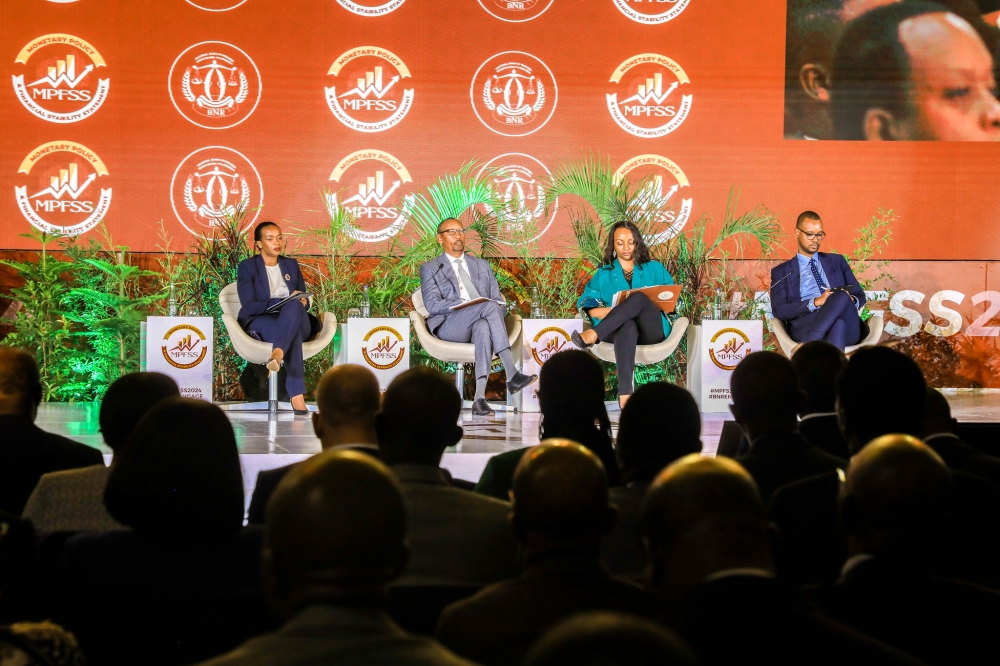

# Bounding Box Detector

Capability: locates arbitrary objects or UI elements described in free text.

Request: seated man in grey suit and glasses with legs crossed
[420,217,538,416]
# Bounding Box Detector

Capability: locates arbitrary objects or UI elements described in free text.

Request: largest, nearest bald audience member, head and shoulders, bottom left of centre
[205,448,467,666]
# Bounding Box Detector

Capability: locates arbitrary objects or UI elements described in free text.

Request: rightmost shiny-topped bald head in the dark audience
[840,435,951,559]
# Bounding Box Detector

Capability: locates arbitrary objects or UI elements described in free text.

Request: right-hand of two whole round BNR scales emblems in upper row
[469,51,559,136]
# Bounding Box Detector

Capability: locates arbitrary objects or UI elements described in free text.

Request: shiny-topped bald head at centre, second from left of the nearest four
[511,439,615,557]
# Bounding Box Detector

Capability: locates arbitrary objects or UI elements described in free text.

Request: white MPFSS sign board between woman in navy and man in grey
[341,317,410,392]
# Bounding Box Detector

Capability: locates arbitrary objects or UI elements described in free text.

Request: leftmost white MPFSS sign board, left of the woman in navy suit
[146,317,214,402]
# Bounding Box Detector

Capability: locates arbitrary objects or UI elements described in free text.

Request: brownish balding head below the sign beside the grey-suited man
[312,364,382,450]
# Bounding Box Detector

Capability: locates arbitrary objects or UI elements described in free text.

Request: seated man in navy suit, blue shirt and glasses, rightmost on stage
[771,210,868,350]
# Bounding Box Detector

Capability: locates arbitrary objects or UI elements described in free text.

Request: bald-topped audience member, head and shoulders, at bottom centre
[437,438,650,666]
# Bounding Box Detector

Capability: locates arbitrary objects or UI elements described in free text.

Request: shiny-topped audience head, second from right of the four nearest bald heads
[640,454,774,598]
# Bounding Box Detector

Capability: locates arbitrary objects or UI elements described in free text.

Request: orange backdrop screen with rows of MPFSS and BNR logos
[0,0,1000,260]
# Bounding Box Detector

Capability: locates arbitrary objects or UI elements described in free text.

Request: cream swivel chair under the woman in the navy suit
[219,282,337,413]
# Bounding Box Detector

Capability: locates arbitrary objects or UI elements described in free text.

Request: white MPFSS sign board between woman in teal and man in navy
[688,319,764,412]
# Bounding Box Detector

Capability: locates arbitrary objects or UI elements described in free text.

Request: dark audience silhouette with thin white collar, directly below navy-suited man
[792,340,851,460]
